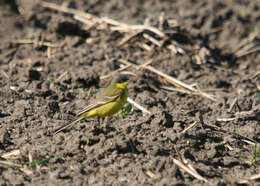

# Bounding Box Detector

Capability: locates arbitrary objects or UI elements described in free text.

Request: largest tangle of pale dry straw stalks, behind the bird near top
[41,2,184,54]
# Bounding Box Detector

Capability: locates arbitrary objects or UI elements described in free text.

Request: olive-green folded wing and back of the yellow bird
[77,86,123,117]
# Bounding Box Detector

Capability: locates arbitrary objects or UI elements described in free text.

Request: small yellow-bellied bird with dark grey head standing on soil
[54,74,128,134]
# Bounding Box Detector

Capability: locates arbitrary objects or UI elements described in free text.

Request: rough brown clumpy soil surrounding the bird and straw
[0,0,260,186]
